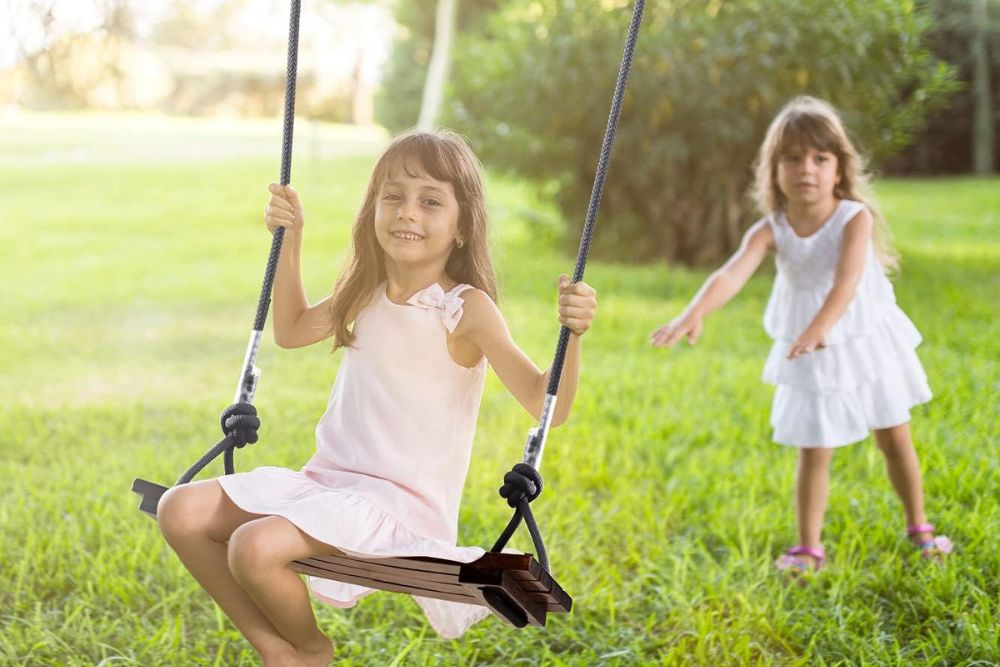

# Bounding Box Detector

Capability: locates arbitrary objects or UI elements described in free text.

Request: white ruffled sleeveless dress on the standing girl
[763,200,931,447]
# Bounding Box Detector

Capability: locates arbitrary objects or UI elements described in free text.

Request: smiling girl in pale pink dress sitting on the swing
[158,132,596,666]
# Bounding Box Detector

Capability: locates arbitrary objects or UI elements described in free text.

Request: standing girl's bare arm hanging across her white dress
[788,209,873,359]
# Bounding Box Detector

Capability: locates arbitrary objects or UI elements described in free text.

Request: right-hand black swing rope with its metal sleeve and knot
[490,0,645,572]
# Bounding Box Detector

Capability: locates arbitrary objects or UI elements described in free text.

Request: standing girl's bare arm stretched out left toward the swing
[651,220,774,347]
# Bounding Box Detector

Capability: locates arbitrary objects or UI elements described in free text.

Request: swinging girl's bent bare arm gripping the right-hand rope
[455,276,597,426]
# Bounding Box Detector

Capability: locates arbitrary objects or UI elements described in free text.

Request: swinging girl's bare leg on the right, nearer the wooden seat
[228,516,333,665]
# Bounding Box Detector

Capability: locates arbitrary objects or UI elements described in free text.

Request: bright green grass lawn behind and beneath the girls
[0,116,1000,667]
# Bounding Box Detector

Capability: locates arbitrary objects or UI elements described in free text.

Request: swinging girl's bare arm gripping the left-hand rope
[265,183,332,348]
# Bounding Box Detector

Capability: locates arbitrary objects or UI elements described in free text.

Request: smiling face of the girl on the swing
[375,168,461,270]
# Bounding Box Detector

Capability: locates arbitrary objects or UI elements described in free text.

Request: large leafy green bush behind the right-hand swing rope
[452,0,952,262]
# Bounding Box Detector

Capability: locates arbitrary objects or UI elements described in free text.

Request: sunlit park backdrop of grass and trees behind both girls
[0,0,1000,667]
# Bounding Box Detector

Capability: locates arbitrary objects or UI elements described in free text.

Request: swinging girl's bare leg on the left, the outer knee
[157,480,296,667]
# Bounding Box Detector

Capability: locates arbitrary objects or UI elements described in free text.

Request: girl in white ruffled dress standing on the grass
[652,97,951,576]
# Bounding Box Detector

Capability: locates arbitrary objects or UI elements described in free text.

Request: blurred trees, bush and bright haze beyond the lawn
[0,0,1000,263]
